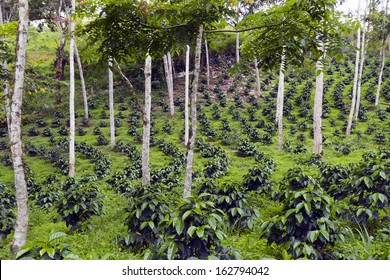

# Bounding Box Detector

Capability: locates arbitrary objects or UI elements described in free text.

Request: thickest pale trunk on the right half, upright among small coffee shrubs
[313,58,324,154]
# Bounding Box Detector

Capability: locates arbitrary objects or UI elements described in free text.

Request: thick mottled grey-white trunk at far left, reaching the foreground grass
[9,0,29,258]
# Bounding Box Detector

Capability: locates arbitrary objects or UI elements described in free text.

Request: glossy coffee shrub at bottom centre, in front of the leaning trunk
[158,194,230,260]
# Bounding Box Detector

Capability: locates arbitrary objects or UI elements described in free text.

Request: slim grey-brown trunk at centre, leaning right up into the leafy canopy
[183,25,203,197]
